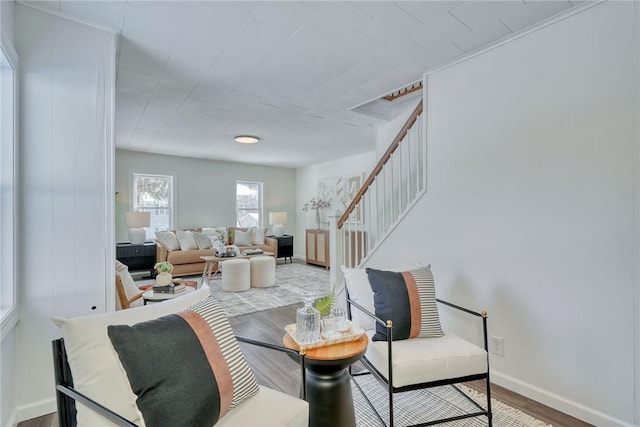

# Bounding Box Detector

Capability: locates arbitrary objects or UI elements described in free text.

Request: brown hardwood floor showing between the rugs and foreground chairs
[18,304,590,427]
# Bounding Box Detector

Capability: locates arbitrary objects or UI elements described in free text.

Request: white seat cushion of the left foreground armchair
[216,386,309,427]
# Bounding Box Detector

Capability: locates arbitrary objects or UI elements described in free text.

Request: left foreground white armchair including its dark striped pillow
[53,286,309,427]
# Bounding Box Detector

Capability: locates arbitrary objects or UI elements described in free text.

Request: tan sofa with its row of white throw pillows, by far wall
[155,227,278,277]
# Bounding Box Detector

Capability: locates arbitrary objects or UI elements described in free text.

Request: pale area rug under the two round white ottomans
[136,263,329,317]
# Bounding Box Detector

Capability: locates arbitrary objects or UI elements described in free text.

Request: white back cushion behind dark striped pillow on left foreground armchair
[52,285,211,426]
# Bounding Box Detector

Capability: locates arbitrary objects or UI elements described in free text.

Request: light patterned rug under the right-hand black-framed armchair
[352,375,551,427]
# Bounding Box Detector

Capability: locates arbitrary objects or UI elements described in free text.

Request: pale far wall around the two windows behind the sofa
[115,150,298,242]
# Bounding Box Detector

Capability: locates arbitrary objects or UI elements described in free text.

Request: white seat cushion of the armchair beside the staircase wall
[365,330,487,387]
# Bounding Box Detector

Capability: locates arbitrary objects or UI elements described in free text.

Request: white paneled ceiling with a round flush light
[19,0,579,167]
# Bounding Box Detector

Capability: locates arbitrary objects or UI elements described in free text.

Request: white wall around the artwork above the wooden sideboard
[293,151,376,259]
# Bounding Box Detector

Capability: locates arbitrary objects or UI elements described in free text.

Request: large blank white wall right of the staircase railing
[369,2,640,426]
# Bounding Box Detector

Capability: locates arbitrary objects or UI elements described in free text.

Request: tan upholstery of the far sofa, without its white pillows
[156,227,278,277]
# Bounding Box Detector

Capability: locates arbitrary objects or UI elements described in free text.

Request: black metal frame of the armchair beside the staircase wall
[345,296,493,427]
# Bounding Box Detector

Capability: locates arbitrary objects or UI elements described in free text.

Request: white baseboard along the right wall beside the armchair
[491,369,635,427]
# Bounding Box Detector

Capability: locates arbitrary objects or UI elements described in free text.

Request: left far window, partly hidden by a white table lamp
[133,173,174,240]
